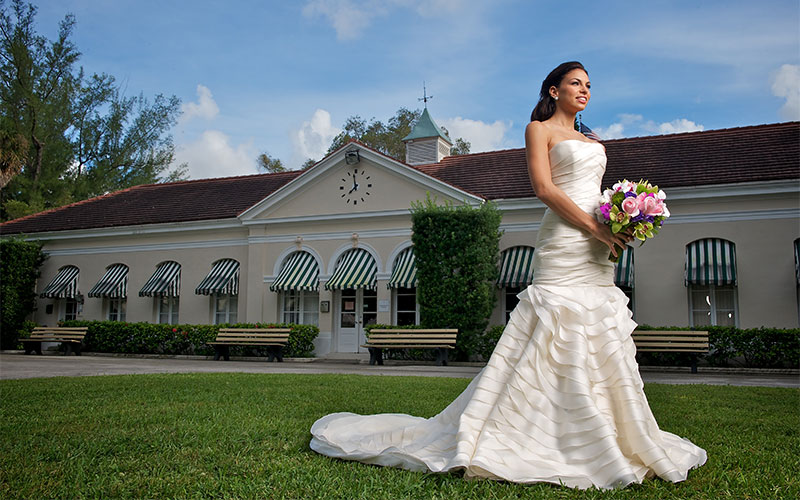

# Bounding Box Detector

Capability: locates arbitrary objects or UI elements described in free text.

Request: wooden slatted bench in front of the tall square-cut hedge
[361,328,458,366]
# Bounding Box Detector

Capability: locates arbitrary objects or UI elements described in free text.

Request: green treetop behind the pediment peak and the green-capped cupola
[327,108,470,161]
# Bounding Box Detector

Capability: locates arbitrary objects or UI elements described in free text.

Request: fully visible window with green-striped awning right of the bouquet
[684,238,739,326]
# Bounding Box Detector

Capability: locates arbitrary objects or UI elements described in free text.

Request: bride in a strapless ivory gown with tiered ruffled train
[311,62,706,488]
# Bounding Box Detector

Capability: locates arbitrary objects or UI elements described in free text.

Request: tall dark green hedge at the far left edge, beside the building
[0,238,47,349]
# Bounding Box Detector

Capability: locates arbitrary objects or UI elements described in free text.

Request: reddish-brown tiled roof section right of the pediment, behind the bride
[415,122,800,199]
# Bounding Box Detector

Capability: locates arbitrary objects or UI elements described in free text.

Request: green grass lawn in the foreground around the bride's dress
[0,374,800,500]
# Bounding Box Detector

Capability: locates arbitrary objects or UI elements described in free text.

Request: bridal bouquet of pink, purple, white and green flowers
[595,179,669,262]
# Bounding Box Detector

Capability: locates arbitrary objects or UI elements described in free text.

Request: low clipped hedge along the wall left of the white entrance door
[57,321,319,358]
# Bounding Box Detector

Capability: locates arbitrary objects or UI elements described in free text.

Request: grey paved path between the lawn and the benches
[0,354,800,388]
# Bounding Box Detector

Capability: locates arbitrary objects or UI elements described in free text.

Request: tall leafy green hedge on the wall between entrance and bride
[411,197,502,360]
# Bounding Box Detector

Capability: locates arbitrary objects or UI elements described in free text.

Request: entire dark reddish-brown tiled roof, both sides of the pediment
[0,122,800,234]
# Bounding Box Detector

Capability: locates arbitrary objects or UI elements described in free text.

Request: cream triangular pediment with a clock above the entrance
[240,142,483,223]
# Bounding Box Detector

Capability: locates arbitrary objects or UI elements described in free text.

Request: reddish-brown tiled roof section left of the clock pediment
[0,171,303,234]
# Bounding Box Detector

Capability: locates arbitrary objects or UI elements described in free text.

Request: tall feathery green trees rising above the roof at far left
[0,0,182,220]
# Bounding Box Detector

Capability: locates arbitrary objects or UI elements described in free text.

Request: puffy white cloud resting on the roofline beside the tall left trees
[175,130,258,179]
